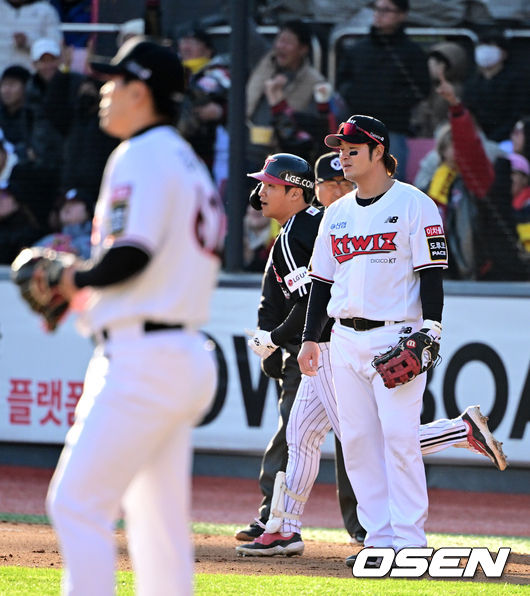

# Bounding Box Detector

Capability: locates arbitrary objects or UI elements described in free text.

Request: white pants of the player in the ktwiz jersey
[331,322,428,550]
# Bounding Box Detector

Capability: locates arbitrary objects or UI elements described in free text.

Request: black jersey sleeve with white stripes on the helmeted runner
[271,207,322,304]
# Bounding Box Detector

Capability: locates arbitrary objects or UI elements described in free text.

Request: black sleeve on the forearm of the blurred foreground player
[74,246,151,288]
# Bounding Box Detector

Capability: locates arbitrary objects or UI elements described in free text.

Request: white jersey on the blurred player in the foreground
[79,126,225,333]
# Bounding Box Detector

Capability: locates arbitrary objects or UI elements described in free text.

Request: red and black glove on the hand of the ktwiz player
[372,329,440,389]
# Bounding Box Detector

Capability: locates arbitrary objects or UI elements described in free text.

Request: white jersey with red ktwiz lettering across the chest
[310,180,447,321]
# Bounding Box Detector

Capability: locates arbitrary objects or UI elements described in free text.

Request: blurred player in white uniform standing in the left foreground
[47,38,225,596]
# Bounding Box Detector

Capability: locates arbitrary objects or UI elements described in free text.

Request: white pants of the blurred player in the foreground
[47,329,216,596]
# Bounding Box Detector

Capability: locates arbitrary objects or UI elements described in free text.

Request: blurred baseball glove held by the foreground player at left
[11,246,76,331]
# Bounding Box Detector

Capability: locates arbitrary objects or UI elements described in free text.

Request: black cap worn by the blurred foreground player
[90,36,186,101]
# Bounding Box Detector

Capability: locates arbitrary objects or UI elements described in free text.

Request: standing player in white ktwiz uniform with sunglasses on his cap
[298,116,447,567]
